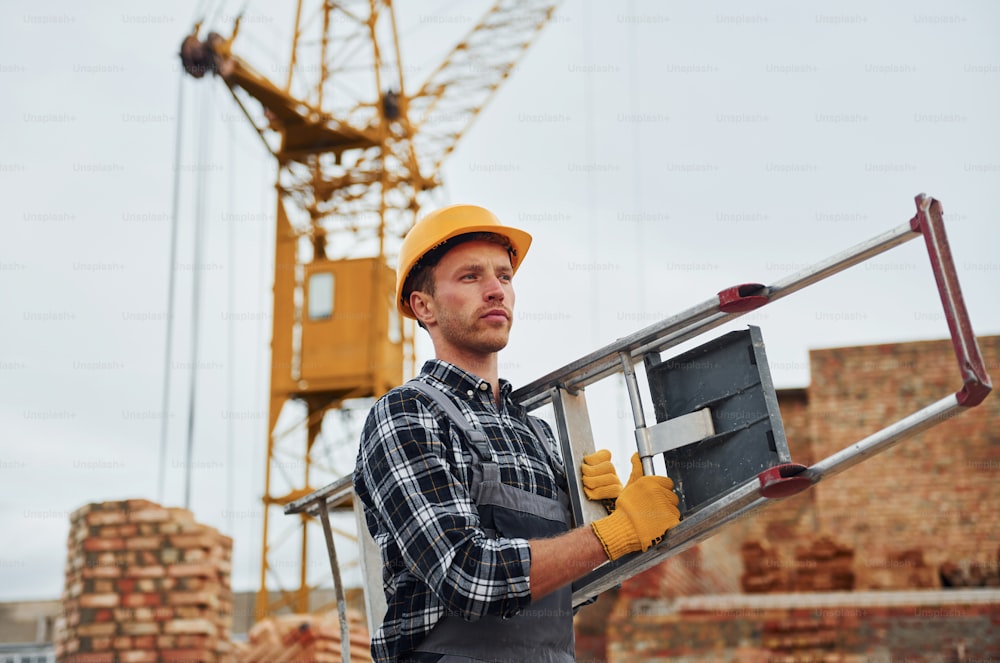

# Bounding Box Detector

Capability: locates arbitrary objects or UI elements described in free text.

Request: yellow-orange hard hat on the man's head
[396,205,531,318]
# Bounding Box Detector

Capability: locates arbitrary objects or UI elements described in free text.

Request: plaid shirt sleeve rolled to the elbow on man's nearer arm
[356,389,531,620]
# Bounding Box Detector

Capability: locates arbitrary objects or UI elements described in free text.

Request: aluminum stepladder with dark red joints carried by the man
[285,194,992,660]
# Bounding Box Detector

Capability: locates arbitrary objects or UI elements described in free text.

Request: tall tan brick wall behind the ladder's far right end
[809,336,1000,588]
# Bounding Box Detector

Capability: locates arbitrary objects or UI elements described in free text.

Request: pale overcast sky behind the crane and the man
[0,0,1000,600]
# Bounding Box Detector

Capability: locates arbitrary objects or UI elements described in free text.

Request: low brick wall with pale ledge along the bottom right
[605,590,1000,663]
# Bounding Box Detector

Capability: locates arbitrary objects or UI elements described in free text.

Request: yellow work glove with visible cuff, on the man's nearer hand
[591,454,681,560]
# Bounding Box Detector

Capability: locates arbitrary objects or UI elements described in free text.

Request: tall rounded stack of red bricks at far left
[56,500,233,663]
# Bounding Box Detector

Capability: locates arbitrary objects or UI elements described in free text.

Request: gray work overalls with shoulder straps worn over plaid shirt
[407,380,576,663]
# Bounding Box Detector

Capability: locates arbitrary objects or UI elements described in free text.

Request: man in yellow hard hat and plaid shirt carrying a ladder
[354,205,680,663]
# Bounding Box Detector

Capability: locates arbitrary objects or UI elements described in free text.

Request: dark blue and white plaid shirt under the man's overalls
[354,360,566,661]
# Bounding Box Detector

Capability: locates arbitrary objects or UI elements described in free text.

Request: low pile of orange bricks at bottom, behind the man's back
[236,613,372,663]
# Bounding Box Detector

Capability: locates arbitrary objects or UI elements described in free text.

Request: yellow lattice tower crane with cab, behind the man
[181,0,559,619]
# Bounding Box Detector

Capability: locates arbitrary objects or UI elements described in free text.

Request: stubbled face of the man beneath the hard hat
[420,241,514,354]
